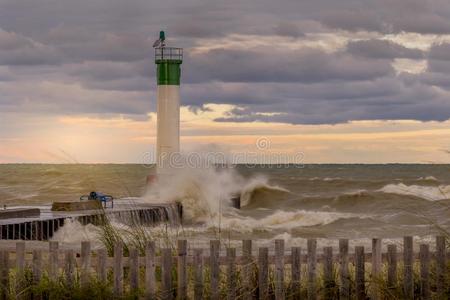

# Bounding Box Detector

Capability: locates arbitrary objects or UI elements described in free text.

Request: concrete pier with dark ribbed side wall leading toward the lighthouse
[0,201,182,241]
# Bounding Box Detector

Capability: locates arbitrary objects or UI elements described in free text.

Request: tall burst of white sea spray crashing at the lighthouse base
[143,163,288,223]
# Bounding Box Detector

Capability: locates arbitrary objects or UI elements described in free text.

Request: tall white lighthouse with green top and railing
[153,31,183,176]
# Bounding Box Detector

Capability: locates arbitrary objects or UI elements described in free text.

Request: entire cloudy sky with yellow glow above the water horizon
[0,0,450,163]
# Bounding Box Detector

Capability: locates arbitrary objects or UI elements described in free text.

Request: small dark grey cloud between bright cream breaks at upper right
[347,39,424,59]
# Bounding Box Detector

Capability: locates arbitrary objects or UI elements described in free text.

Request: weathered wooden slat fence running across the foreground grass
[0,236,450,299]
